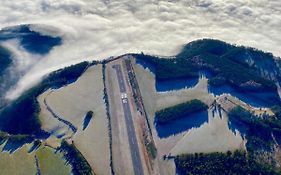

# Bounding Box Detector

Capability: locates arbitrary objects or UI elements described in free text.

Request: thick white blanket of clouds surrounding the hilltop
[0,0,281,99]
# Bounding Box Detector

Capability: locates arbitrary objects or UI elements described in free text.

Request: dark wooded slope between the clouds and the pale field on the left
[0,62,94,135]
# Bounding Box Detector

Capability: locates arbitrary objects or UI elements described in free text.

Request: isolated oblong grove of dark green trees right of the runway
[155,99,208,123]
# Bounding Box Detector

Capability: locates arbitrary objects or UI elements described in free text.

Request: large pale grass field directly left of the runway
[39,65,110,174]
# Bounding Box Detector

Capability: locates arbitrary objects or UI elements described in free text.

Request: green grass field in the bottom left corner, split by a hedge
[0,144,71,175]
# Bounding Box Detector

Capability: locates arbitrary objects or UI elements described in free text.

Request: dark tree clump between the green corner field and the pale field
[58,140,94,175]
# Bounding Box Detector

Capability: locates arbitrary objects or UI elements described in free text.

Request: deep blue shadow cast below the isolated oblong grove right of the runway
[155,111,208,138]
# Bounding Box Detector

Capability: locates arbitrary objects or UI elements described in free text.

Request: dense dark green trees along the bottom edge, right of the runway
[175,151,280,175]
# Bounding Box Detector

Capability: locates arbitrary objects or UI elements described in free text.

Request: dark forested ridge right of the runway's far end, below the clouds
[134,39,279,93]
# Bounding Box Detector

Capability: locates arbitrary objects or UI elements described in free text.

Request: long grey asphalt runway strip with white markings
[112,64,143,175]
